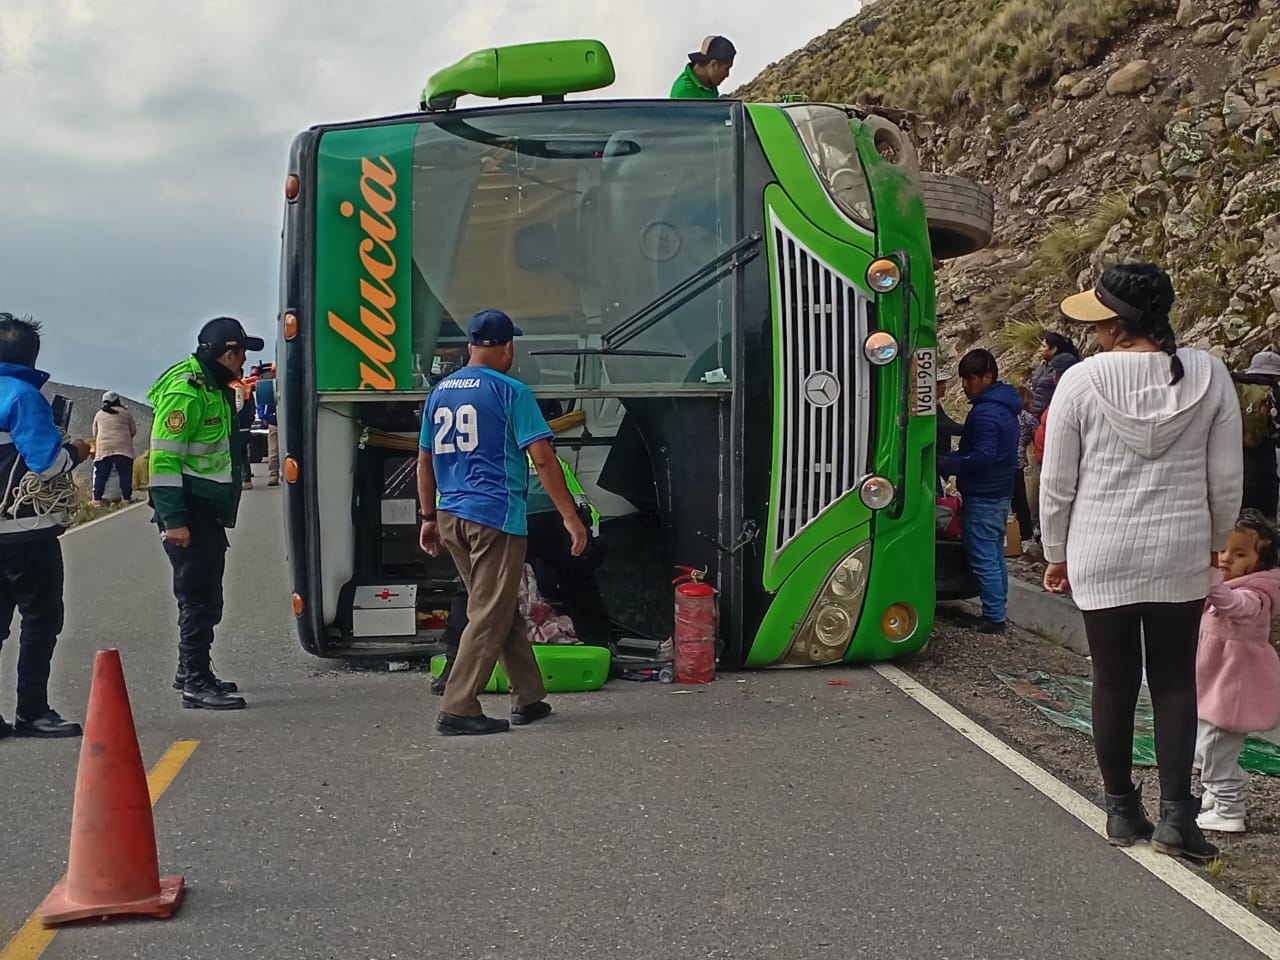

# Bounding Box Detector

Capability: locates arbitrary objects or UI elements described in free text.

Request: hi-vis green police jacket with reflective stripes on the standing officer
[147,355,244,530]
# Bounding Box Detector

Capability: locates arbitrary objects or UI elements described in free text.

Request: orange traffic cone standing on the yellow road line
[40,650,183,927]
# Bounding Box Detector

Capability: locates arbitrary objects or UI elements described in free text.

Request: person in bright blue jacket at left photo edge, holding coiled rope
[0,314,88,737]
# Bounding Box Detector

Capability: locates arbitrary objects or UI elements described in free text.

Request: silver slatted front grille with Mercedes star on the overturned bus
[772,221,870,558]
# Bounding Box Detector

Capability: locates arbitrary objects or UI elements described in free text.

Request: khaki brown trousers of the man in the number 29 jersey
[439,511,547,717]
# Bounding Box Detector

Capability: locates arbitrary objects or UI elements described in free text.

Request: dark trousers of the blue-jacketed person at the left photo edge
[0,536,63,721]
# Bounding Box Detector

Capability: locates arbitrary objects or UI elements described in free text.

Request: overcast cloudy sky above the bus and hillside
[0,0,859,397]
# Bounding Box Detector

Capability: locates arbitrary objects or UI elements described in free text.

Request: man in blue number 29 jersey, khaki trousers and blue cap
[417,310,586,736]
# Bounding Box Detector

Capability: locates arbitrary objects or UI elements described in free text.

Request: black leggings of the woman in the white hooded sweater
[1083,600,1204,800]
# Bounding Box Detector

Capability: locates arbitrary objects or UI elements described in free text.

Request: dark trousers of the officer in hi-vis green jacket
[164,502,229,675]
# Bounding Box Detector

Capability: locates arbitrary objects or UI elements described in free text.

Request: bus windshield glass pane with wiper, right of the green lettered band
[412,102,739,392]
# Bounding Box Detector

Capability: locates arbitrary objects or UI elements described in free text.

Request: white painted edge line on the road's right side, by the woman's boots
[872,664,1280,960]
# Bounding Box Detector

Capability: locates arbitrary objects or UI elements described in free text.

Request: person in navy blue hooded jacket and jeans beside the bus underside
[942,349,1023,634]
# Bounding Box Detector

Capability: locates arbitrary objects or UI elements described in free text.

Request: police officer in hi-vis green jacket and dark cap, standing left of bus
[147,316,265,710]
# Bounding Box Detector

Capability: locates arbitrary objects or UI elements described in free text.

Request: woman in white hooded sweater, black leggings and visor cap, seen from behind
[1039,264,1243,860]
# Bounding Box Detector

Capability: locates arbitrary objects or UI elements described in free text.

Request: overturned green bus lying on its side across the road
[278,45,937,667]
